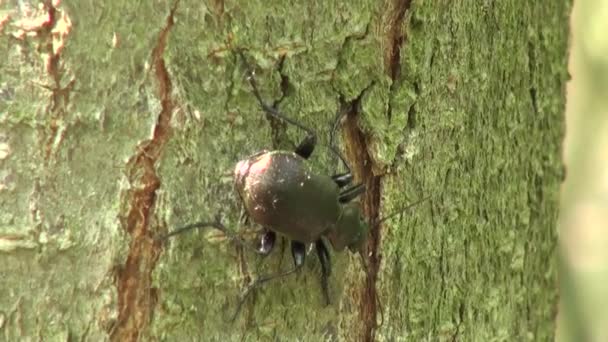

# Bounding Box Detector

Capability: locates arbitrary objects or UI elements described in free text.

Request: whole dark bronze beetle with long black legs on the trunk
[162,51,426,321]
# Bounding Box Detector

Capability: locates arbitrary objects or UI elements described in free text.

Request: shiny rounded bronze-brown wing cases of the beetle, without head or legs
[234,151,341,243]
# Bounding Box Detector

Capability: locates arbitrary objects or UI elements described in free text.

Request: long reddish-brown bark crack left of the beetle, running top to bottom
[109,1,179,341]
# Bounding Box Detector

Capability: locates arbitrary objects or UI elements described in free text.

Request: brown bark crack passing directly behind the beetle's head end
[344,93,381,341]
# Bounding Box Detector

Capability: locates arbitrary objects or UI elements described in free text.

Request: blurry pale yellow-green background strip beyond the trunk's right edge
[558,0,608,341]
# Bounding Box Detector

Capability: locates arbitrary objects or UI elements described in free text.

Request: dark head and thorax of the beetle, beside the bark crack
[327,202,369,253]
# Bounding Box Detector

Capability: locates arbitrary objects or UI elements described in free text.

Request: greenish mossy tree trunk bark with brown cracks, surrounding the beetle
[0,0,570,341]
